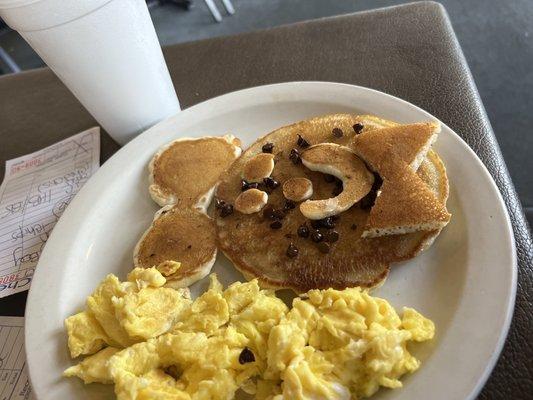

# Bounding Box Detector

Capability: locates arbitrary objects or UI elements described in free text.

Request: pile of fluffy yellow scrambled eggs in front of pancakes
[64,268,435,400]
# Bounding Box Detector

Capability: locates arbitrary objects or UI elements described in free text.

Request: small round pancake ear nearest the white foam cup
[149,135,241,211]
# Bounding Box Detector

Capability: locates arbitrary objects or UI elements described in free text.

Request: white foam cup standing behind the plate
[0,0,180,144]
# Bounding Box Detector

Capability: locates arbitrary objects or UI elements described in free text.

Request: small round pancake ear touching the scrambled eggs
[133,206,217,288]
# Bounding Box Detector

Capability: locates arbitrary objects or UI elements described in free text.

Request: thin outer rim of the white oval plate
[24,81,518,400]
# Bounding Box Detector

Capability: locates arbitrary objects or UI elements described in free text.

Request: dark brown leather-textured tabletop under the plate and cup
[0,2,533,399]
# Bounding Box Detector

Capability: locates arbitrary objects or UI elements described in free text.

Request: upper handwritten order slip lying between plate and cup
[0,128,100,296]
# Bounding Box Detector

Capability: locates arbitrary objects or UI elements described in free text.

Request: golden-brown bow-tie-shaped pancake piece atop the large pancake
[352,123,450,236]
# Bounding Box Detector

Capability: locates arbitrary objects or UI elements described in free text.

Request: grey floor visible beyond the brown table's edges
[0,0,533,226]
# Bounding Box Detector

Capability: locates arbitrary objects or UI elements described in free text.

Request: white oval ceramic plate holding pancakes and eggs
[26,82,516,400]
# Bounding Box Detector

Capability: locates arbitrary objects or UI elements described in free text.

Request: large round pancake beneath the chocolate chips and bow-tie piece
[216,114,447,292]
